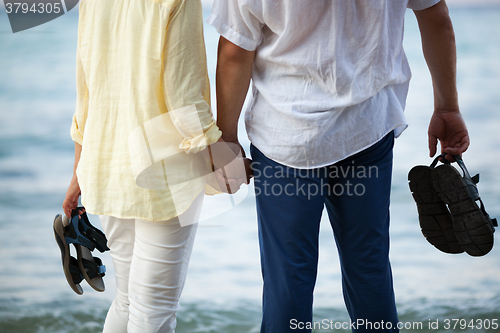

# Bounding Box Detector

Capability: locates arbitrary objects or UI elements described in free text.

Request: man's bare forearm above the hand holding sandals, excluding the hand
[415,0,459,112]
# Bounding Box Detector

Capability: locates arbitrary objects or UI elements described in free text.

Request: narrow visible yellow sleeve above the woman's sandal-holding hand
[70,43,89,145]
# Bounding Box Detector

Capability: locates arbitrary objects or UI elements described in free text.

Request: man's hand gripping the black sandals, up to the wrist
[428,110,470,162]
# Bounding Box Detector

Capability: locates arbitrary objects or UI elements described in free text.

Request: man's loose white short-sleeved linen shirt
[208,0,440,169]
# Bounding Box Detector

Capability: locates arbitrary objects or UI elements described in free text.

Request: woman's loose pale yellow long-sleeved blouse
[71,0,221,221]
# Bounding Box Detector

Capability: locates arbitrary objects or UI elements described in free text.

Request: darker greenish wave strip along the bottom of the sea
[0,296,500,333]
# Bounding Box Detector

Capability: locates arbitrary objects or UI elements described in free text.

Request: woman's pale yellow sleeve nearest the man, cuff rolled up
[163,0,222,153]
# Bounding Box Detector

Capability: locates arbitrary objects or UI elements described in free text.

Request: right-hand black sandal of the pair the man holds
[432,156,498,256]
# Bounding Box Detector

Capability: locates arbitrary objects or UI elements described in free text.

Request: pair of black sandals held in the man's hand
[408,154,498,257]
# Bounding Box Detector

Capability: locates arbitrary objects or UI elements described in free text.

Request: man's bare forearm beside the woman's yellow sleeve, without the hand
[216,37,255,142]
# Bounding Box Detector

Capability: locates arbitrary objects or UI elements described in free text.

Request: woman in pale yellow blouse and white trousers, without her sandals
[63,0,221,333]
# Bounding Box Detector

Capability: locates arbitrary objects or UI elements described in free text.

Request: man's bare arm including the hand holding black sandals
[415,0,469,160]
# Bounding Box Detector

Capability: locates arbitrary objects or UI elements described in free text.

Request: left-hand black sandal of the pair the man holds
[408,156,464,254]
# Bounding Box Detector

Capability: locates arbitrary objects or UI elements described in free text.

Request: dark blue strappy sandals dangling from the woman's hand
[54,207,109,295]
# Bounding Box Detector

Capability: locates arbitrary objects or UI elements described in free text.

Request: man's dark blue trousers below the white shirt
[251,133,398,333]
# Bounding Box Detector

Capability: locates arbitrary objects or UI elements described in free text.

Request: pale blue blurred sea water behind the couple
[0,5,500,333]
